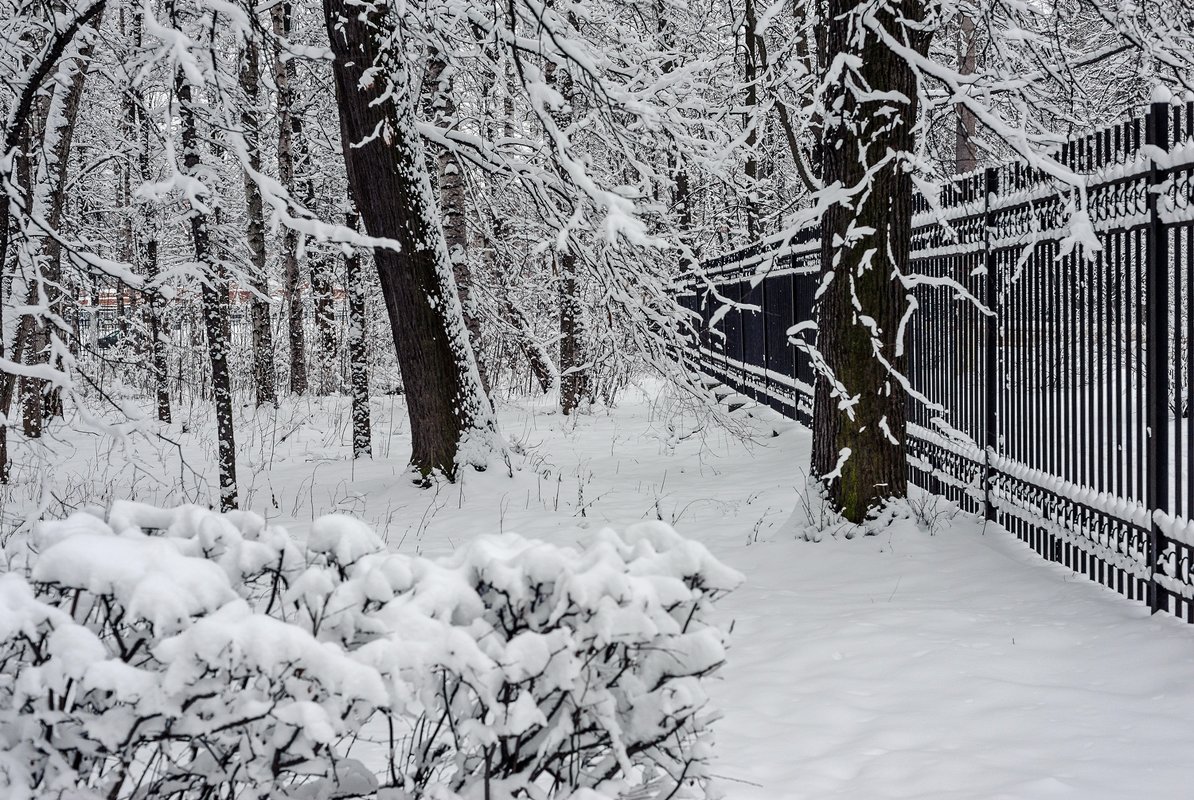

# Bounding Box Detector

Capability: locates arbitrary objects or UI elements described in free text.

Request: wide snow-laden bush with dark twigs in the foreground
[0,503,740,800]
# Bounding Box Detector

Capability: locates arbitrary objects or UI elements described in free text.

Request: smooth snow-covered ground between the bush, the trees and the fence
[0,392,1194,800]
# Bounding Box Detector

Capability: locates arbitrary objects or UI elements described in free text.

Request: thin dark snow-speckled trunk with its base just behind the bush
[170,47,236,511]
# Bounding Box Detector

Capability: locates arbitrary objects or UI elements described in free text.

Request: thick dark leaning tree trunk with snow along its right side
[324,0,497,478]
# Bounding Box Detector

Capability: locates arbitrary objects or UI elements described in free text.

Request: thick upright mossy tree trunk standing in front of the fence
[812,0,930,523]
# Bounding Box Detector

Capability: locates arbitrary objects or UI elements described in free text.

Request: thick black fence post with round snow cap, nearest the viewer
[1145,88,1169,614]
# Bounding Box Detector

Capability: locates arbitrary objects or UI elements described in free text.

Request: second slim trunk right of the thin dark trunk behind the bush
[270,0,307,394]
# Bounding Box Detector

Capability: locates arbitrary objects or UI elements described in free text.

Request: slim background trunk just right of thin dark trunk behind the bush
[240,38,278,407]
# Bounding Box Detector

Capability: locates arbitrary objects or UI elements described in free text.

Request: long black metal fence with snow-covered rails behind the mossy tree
[682,103,1194,622]
